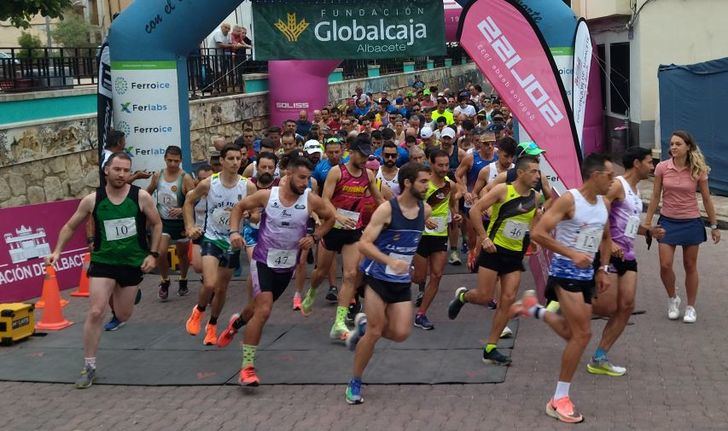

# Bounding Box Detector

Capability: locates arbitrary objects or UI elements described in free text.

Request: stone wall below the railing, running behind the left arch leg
[0,64,484,208]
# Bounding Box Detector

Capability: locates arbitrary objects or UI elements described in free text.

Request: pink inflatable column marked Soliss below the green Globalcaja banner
[268,60,341,125]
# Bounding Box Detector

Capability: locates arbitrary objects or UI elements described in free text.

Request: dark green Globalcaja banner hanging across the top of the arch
[252,0,445,60]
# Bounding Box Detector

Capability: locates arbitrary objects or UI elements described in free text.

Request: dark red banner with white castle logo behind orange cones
[0,199,87,302]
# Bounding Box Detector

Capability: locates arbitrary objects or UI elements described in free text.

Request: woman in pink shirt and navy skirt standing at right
[645,130,720,323]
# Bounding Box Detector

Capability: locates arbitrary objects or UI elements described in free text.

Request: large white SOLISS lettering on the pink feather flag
[478,16,564,127]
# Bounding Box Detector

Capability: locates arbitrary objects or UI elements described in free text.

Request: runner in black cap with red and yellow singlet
[301,134,383,342]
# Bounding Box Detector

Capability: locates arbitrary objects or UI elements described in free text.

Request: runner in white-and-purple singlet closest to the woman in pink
[587,147,665,377]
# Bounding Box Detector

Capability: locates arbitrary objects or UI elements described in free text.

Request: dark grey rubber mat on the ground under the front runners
[0,314,518,386]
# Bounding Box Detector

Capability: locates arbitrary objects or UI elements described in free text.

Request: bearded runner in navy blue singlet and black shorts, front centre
[345,163,431,404]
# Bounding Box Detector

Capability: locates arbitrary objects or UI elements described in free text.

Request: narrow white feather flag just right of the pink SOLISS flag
[571,20,592,154]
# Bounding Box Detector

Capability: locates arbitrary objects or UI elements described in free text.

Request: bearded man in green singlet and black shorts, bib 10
[46,153,162,389]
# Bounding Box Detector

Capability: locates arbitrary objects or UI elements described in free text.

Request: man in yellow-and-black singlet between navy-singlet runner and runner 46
[412,150,462,330]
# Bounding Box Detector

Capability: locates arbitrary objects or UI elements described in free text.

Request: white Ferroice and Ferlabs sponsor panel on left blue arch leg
[111,61,182,186]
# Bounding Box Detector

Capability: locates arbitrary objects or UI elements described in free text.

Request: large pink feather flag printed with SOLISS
[459,0,581,188]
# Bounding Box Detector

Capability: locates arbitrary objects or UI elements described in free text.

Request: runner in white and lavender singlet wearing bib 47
[225,157,335,386]
